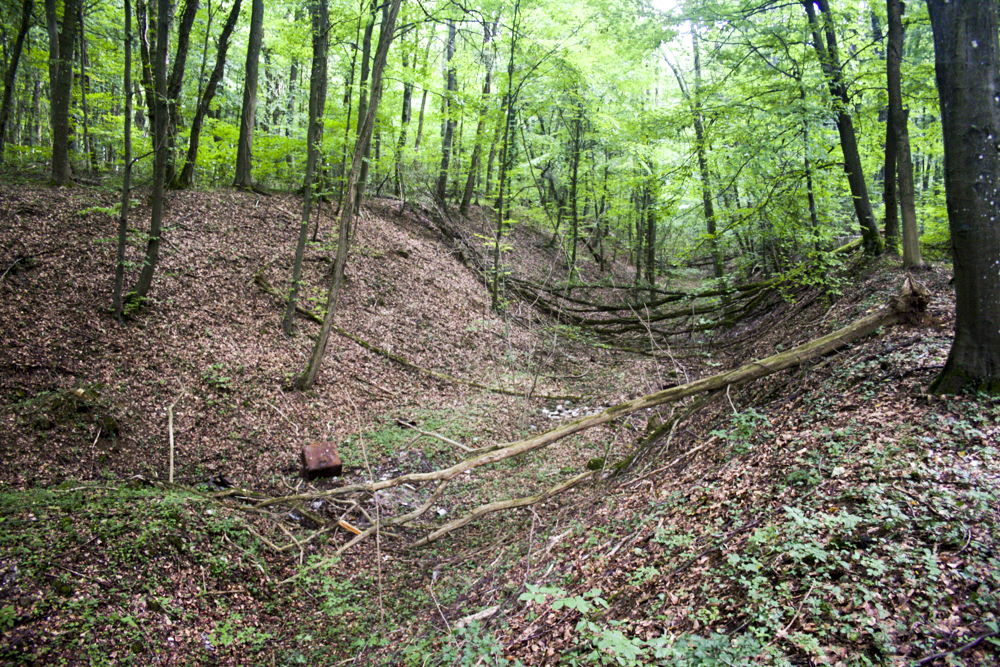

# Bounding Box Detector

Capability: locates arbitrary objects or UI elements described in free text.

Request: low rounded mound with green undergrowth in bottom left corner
[0,482,288,665]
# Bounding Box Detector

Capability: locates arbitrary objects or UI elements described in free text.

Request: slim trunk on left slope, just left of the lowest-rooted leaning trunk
[281,0,330,334]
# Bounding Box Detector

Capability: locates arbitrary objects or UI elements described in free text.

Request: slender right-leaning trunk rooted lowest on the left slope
[296,0,402,390]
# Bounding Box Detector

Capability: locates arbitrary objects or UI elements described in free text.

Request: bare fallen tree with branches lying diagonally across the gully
[253,279,929,553]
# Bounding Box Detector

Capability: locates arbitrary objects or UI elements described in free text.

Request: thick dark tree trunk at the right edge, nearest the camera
[927,0,1000,394]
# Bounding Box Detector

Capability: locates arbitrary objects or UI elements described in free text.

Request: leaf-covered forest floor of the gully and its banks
[0,179,1000,667]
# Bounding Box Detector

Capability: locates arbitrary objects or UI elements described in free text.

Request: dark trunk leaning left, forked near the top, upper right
[802,0,882,255]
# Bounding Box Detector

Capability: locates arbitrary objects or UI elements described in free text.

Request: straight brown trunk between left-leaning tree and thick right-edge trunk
[886,0,923,268]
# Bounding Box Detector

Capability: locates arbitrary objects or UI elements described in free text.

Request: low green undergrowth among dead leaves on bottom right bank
[472,392,1000,666]
